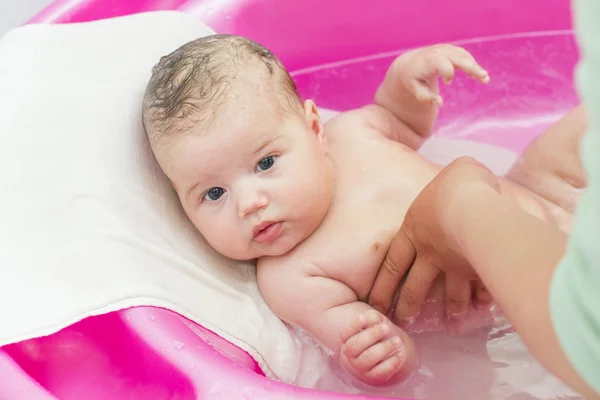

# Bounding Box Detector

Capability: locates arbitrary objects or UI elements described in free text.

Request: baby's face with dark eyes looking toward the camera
[159,98,334,260]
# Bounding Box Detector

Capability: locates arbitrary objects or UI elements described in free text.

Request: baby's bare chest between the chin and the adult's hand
[303,136,419,300]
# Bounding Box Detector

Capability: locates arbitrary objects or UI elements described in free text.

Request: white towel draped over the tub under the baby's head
[0,12,320,384]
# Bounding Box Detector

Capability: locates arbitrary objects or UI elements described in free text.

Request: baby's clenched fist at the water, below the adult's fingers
[340,310,416,385]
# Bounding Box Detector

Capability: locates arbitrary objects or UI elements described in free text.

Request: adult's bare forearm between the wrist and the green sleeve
[455,191,594,398]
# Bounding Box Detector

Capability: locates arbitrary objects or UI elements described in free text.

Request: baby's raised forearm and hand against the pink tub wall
[375,44,489,150]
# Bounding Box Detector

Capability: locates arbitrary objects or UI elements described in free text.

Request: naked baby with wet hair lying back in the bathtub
[143,35,570,385]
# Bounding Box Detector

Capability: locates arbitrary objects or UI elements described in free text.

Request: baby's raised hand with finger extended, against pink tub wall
[399,44,490,106]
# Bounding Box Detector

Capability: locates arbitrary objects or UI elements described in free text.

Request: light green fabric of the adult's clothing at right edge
[550,0,600,393]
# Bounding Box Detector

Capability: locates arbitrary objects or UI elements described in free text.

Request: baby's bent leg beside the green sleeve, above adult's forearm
[506,105,587,213]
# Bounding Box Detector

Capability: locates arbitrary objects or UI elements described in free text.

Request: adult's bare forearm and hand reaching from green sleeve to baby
[360,157,599,399]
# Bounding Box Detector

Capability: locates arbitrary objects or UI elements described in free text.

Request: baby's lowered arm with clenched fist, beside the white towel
[258,264,417,385]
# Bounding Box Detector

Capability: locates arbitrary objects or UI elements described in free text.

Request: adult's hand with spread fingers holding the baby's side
[369,157,500,321]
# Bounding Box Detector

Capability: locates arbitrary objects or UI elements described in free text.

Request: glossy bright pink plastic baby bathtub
[0,0,578,400]
